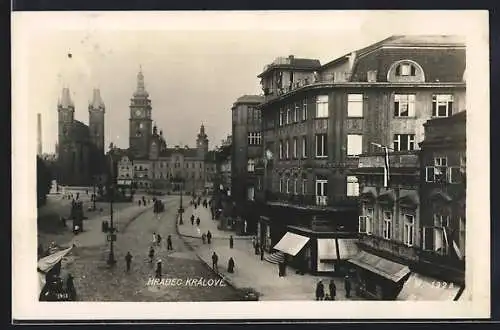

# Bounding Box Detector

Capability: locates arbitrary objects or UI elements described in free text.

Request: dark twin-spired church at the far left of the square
[56,88,105,185]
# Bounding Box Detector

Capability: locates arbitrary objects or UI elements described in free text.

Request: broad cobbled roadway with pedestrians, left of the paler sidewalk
[58,197,241,301]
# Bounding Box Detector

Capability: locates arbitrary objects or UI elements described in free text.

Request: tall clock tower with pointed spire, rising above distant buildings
[129,69,152,157]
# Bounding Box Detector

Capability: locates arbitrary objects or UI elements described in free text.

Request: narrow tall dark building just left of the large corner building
[231,95,264,233]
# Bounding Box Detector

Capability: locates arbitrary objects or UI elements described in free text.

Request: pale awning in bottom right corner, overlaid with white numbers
[397,273,460,301]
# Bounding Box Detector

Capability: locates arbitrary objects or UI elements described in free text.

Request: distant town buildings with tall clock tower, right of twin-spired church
[117,71,213,194]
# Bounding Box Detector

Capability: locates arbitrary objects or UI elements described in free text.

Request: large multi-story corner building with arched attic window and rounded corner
[259,36,465,271]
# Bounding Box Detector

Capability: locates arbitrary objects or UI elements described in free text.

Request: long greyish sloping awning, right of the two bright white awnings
[348,251,410,282]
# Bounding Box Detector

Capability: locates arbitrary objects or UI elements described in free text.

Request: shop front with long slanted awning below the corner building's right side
[349,251,410,300]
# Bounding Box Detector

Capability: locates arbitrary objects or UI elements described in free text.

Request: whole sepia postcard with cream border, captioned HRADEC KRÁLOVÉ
[12,10,490,321]
